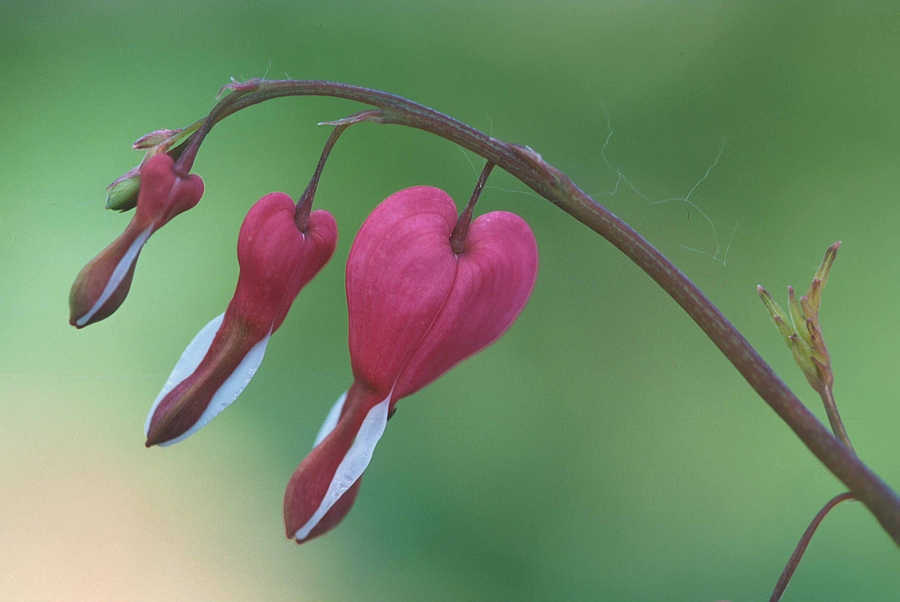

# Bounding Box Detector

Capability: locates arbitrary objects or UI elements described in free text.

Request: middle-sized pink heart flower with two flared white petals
[144,192,337,447]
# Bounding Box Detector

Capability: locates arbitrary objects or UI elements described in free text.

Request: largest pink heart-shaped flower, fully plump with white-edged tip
[284,186,538,543]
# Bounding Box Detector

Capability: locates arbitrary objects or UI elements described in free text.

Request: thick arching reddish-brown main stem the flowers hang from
[176,80,900,545]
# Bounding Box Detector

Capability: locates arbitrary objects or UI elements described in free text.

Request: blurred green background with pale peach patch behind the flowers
[0,0,900,602]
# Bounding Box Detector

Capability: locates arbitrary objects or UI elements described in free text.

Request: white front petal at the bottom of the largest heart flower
[294,391,393,540]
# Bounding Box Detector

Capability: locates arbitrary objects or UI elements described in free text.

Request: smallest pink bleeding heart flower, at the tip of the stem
[69,153,203,328]
